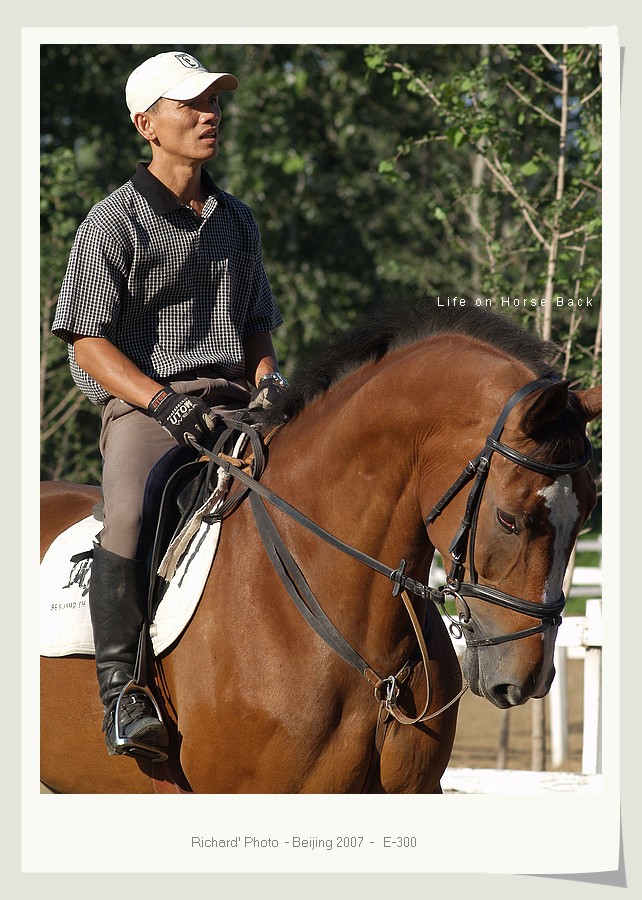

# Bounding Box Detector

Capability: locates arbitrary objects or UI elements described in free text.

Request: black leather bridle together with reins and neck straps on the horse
[192,378,592,728]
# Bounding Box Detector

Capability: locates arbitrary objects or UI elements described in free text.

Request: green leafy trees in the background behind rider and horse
[41,44,601,512]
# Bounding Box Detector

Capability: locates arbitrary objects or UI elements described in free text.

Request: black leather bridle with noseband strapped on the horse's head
[425,378,592,647]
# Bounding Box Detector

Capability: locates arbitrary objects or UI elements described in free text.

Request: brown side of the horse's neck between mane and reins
[260,335,528,584]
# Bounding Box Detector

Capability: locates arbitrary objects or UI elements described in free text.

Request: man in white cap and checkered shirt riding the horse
[52,51,285,755]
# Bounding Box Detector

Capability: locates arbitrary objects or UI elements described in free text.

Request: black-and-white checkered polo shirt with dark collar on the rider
[52,163,282,404]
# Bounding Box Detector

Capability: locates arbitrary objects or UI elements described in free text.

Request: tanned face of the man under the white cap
[146,88,221,161]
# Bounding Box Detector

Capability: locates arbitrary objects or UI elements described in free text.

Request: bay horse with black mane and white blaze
[41,302,601,794]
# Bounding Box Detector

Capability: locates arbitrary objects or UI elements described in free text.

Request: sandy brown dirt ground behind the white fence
[450,660,584,772]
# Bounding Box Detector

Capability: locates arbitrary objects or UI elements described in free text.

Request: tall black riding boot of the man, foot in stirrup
[89,544,168,758]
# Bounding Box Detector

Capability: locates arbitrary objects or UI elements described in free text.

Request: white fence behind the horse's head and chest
[438,541,602,794]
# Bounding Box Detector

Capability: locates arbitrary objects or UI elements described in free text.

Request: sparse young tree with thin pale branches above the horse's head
[366,45,602,383]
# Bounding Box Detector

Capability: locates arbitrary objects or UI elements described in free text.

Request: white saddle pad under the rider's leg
[40,510,221,656]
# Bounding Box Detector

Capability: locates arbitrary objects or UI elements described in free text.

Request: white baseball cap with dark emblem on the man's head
[125,50,239,122]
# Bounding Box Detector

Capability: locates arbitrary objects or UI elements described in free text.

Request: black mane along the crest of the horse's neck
[260,300,559,424]
